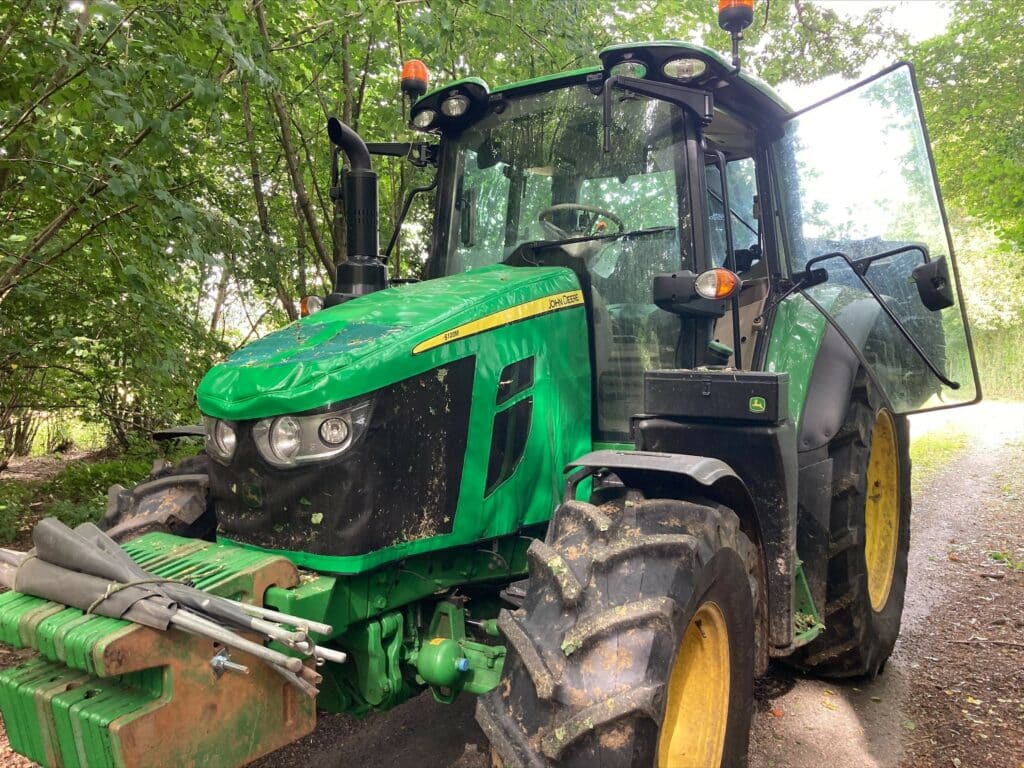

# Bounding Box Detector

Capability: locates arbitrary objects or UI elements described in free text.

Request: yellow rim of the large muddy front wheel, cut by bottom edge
[657,602,729,768]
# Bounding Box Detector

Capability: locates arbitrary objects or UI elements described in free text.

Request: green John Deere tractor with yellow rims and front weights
[0,3,980,768]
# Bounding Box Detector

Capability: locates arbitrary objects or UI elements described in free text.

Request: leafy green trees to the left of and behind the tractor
[0,0,899,454]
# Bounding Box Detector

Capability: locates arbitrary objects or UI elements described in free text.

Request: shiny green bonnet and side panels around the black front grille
[205,266,591,573]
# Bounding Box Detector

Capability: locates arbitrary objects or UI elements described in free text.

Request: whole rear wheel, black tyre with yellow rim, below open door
[791,383,910,678]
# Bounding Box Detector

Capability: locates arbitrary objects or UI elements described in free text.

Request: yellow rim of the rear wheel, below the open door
[864,410,900,612]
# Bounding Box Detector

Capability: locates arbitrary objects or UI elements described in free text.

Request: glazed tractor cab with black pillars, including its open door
[411,42,978,443]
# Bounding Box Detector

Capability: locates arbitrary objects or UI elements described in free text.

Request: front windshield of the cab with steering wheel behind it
[428,84,695,440]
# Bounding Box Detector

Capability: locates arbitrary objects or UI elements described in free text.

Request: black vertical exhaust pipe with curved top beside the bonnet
[324,117,387,306]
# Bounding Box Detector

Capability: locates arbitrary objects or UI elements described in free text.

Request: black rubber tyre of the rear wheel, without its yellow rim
[788,381,910,678]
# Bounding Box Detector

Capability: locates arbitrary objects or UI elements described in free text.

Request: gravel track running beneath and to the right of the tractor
[266,402,1024,768]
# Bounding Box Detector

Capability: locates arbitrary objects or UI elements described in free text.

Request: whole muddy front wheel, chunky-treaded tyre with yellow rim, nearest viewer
[477,492,757,768]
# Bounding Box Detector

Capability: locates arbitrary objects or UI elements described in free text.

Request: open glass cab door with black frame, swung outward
[771,63,981,414]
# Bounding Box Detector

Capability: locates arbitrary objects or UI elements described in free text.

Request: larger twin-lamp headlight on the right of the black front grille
[253,402,371,467]
